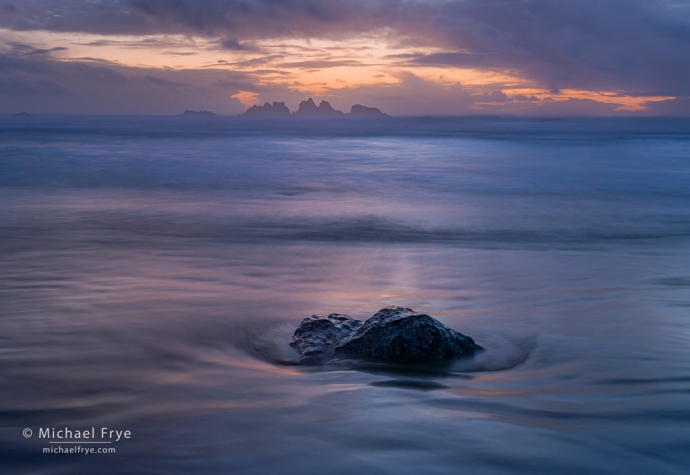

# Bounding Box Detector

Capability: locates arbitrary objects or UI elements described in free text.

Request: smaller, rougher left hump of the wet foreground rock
[290,313,362,361]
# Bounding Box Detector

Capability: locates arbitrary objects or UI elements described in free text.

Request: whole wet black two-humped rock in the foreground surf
[290,306,482,363]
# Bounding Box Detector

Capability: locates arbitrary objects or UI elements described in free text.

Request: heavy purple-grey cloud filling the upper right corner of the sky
[436,0,690,95]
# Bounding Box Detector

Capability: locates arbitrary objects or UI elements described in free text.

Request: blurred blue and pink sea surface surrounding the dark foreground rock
[0,119,690,474]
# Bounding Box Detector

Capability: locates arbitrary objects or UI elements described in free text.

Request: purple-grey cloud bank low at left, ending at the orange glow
[0,54,247,115]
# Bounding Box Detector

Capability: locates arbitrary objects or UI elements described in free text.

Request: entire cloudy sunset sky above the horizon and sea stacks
[0,0,690,117]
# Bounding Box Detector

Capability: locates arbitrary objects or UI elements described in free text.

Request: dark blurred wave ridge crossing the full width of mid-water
[0,214,690,249]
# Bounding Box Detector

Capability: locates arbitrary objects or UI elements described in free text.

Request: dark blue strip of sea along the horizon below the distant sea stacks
[0,116,690,141]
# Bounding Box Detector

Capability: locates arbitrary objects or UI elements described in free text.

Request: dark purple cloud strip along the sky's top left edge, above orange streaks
[0,0,400,37]
